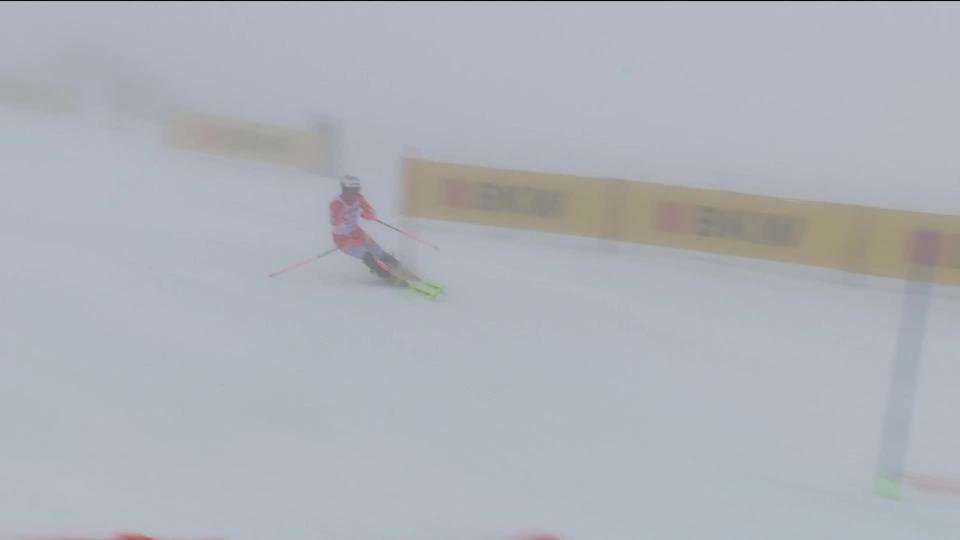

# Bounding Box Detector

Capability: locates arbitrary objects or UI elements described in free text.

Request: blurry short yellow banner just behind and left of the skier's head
[166,111,335,174]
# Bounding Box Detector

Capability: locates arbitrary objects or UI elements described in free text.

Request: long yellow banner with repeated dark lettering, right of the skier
[405,160,960,284]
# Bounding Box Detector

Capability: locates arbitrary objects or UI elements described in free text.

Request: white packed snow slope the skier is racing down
[0,110,960,540]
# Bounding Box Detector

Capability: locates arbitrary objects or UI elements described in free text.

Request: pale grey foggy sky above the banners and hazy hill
[0,2,960,212]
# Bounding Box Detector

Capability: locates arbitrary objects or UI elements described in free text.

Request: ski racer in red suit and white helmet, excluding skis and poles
[330,176,400,281]
